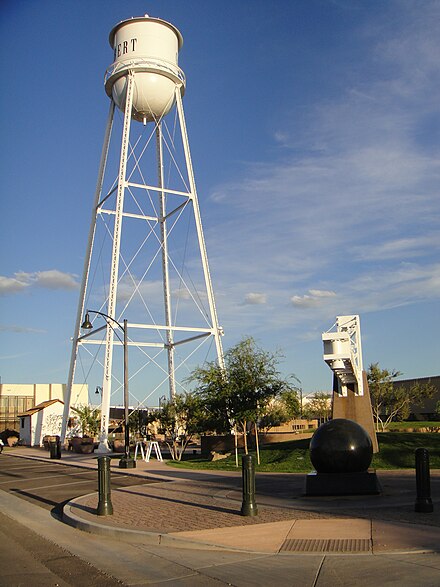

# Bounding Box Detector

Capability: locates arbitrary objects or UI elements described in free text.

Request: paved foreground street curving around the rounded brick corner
[0,491,440,587]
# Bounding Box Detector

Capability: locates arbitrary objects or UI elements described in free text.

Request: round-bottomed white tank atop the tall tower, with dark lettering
[105,15,185,123]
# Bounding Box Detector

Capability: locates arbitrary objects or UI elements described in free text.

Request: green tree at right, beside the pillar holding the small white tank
[367,363,436,431]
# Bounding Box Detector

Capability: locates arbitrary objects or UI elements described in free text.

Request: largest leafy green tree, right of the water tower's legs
[189,337,291,454]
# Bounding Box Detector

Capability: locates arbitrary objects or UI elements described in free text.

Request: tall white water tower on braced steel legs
[62,15,223,451]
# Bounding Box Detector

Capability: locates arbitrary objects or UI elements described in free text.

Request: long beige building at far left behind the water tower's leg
[0,383,89,432]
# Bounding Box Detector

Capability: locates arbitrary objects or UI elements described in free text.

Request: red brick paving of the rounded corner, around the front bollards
[69,470,440,534]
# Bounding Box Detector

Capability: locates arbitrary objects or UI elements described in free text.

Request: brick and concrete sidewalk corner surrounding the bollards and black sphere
[4,447,440,556]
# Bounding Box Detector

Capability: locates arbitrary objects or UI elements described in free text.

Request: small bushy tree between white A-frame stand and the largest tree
[147,393,205,461]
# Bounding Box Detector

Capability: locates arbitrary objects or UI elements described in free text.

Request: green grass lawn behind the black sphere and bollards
[169,432,440,473]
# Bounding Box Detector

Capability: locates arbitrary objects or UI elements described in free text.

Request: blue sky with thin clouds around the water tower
[0,0,440,404]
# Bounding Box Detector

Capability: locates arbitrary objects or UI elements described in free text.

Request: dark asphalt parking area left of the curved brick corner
[0,454,154,517]
